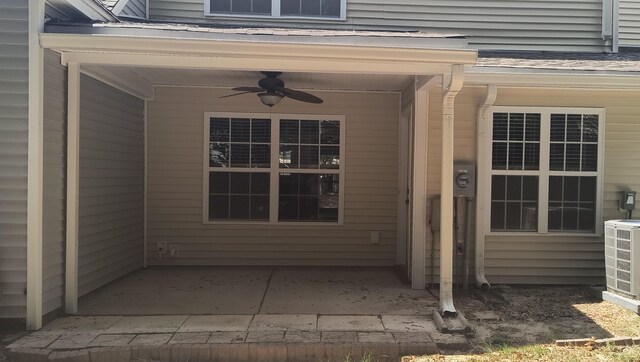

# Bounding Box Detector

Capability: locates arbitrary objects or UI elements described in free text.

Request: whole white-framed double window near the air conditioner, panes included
[489,107,604,233]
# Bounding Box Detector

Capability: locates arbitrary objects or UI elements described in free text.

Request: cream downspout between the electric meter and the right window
[475,84,498,289]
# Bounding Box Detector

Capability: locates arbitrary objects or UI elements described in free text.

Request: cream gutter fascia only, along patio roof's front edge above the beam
[40,33,477,71]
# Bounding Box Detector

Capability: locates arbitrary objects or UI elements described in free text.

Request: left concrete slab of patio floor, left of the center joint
[78,267,272,315]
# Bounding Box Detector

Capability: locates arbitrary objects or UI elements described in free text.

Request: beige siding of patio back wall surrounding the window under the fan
[148,87,399,266]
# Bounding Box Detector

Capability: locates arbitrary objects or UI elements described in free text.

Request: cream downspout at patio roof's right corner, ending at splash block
[440,64,464,316]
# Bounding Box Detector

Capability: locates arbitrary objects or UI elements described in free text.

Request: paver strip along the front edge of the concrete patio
[2,314,466,361]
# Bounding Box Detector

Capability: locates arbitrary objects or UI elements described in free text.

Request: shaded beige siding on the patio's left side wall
[78,75,144,295]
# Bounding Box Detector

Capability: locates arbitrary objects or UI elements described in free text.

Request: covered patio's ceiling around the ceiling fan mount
[83,65,413,92]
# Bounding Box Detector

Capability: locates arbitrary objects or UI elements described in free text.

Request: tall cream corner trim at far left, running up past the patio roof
[26,0,44,330]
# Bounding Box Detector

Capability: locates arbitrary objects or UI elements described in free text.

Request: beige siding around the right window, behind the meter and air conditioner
[427,88,640,284]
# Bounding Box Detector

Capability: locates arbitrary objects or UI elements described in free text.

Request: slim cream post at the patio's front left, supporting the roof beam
[64,63,80,314]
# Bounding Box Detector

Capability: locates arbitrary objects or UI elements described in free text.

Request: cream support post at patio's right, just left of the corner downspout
[411,77,439,289]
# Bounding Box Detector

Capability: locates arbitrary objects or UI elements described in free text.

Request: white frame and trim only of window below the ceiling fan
[202,112,346,226]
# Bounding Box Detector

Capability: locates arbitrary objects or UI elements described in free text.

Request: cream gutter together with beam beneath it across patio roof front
[40,33,477,75]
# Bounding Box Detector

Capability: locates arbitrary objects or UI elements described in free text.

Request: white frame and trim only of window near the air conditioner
[478,106,606,237]
